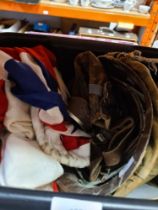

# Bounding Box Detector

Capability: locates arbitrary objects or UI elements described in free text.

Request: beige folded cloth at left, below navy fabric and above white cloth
[4,80,34,139]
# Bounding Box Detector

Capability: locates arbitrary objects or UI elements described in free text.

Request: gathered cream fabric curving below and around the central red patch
[31,107,90,168]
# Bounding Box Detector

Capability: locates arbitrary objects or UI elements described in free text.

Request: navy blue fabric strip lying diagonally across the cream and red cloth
[5,59,69,119]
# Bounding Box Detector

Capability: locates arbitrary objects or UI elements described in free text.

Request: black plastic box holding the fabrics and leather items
[0,33,158,210]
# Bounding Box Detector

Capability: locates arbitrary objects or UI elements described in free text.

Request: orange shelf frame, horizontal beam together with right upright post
[0,0,158,46]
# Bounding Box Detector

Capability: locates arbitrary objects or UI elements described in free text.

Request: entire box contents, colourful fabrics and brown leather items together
[0,46,158,196]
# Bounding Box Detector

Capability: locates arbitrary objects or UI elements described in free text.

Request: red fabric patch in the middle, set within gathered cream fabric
[61,135,89,151]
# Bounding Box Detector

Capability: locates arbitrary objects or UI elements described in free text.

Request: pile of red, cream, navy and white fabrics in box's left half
[0,46,90,189]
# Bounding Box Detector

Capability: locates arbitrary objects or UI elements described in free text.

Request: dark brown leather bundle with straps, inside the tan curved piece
[62,52,153,195]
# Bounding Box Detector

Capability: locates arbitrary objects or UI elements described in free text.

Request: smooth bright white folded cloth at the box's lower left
[0,134,63,189]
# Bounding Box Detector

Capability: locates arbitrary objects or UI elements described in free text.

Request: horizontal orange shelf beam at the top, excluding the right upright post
[0,0,150,26]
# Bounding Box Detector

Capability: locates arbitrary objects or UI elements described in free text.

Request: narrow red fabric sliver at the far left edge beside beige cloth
[0,80,8,130]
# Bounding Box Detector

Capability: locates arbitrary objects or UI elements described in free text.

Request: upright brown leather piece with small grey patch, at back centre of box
[69,52,106,128]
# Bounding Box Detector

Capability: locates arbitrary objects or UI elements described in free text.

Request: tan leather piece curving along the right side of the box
[100,51,158,196]
